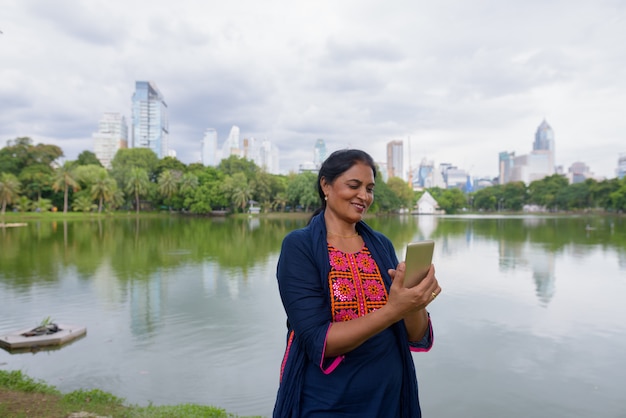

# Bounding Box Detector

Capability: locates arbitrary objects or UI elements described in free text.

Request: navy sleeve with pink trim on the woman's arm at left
[276,231,343,374]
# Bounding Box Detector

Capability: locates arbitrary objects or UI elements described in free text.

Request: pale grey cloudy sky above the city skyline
[0,0,626,177]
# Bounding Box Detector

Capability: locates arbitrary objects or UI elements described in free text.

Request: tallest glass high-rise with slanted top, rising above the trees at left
[131,81,169,158]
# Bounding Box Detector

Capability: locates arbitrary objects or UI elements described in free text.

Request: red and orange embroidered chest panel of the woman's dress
[328,244,387,322]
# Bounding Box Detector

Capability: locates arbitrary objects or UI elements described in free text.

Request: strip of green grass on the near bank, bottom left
[0,370,262,418]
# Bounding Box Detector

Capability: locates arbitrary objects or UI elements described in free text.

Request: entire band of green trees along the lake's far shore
[0,137,626,215]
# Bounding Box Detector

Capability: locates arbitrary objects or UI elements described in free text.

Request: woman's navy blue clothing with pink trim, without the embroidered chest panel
[274,212,433,418]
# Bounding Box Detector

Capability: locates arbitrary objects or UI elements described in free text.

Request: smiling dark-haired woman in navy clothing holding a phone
[274,150,441,418]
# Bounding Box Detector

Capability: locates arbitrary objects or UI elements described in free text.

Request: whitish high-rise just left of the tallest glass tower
[92,112,128,168]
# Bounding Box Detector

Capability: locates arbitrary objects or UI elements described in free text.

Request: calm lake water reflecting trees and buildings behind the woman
[0,215,626,418]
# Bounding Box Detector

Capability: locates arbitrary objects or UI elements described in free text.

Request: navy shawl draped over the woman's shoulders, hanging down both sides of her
[273,211,422,418]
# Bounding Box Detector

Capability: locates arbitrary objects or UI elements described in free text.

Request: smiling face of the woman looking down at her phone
[321,162,374,223]
